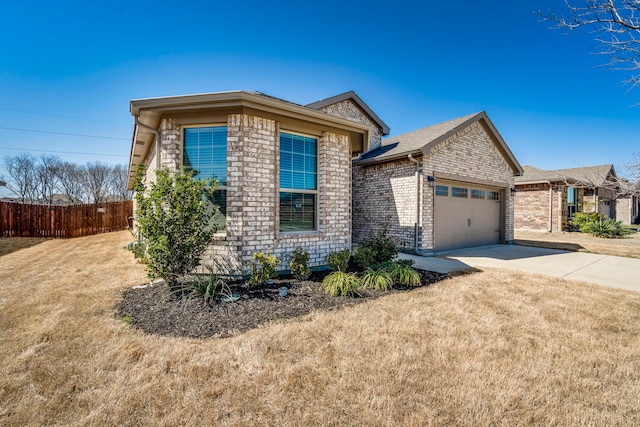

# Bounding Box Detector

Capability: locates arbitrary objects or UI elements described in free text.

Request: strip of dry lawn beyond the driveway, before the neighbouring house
[515,230,640,258]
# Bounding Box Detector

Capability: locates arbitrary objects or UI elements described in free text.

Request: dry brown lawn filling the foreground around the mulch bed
[0,232,640,426]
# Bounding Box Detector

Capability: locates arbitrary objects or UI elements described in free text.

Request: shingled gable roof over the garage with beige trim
[358,111,522,175]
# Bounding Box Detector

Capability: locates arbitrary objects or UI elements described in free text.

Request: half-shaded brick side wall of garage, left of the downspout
[353,159,416,248]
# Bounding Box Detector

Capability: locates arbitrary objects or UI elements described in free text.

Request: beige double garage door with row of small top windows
[434,180,502,251]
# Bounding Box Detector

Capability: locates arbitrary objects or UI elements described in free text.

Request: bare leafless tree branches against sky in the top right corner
[538,0,640,88]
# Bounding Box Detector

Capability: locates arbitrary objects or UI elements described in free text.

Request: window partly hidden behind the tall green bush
[182,126,227,230]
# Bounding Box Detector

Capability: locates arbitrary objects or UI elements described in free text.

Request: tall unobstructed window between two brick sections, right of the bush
[280,132,318,232]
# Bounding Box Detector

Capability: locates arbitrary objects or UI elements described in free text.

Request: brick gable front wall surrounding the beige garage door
[422,122,514,250]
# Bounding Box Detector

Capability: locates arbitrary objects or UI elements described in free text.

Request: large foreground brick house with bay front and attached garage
[129,91,521,271]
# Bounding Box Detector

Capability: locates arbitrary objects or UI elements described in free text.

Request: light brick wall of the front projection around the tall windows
[154,114,351,274]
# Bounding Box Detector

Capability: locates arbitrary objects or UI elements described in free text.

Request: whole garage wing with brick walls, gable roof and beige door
[353,112,522,255]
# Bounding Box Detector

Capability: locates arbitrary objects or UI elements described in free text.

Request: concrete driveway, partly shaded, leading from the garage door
[400,245,640,292]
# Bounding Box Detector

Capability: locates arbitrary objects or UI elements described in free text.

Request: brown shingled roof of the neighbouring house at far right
[516,164,616,187]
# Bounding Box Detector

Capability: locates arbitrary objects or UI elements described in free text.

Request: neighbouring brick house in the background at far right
[514,164,638,232]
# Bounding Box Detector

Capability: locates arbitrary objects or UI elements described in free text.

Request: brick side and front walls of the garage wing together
[353,122,514,250]
